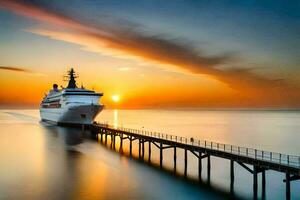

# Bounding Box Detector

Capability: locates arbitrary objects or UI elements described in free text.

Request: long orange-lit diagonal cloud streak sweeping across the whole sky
[0,0,299,105]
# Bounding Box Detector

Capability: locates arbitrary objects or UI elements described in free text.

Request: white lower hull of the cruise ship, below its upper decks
[40,104,103,125]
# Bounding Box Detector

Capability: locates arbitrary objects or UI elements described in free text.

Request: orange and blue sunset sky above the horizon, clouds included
[0,0,300,109]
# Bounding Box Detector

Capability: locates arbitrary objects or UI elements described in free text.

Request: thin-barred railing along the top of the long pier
[98,123,300,168]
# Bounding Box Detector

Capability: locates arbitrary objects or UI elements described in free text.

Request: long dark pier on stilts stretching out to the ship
[91,123,300,199]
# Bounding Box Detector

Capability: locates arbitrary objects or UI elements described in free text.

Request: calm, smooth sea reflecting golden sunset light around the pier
[0,110,300,199]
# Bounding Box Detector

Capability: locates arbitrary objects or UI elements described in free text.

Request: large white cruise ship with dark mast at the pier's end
[40,68,104,125]
